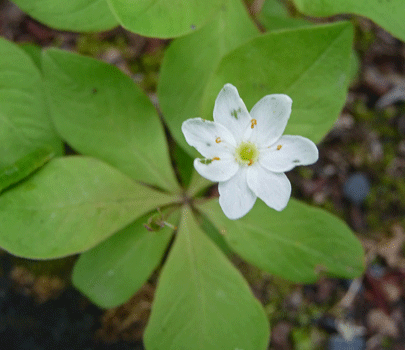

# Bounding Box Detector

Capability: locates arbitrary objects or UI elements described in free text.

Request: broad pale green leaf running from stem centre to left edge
[0,156,176,259]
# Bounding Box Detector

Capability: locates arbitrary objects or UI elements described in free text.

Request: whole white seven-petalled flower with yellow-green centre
[181,84,318,220]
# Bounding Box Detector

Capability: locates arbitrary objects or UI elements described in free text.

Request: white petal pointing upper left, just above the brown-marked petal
[181,118,236,158]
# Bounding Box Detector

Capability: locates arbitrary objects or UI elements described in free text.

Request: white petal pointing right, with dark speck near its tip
[259,135,319,173]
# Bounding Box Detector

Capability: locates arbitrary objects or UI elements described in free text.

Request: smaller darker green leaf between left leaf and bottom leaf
[72,211,177,308]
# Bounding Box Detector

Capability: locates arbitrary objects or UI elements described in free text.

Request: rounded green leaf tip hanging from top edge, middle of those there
[108,0,227,38]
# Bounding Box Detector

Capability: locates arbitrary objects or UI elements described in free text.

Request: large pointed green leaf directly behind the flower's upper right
[203,22,353,143]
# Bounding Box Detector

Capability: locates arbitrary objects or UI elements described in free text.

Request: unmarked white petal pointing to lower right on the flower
[247,164,291,211]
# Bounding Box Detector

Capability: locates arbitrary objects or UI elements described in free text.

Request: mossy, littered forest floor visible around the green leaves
[0,0,405,350]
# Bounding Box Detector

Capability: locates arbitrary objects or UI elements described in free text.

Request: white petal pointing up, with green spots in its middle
[214,84,251,143]
